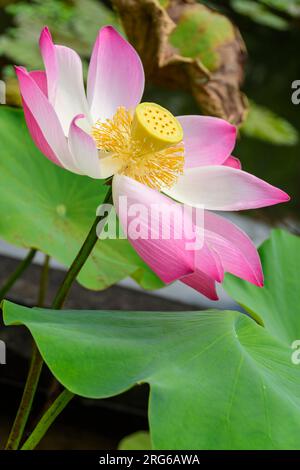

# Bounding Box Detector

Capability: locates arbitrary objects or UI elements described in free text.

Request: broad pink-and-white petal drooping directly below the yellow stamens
[113,175,194,283]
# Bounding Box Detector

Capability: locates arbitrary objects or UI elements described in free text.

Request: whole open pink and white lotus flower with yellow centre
[16,26,289,299]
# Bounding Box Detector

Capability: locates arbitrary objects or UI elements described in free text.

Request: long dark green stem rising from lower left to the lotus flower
[6,186,112,450]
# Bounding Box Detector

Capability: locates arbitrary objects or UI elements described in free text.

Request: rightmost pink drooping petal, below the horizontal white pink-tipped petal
[204,211,263,286]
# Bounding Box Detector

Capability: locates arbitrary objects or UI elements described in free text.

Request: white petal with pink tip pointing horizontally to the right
[164,166,289,211]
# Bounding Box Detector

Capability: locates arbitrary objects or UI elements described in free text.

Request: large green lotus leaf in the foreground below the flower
[3,301,300,449]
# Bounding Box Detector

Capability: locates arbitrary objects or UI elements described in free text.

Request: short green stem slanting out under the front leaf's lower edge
[21,390,74,450]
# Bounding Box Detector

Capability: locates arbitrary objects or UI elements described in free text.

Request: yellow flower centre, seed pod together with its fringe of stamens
[92,103,184,189]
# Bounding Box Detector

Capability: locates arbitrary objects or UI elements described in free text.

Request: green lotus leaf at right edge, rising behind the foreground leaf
[224,230,300,346]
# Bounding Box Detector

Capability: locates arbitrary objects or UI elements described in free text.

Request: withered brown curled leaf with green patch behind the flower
[113,0,247,125]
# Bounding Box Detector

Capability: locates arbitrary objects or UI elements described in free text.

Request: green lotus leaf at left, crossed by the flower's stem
[0,106,162,289]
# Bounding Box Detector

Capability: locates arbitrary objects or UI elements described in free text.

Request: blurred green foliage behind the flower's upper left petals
[0,0,119,74]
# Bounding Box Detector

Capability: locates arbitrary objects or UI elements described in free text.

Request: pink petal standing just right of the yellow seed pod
[177,116,236,168]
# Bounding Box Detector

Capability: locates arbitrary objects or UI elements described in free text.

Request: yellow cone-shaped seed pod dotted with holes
[132,103,183,151]
